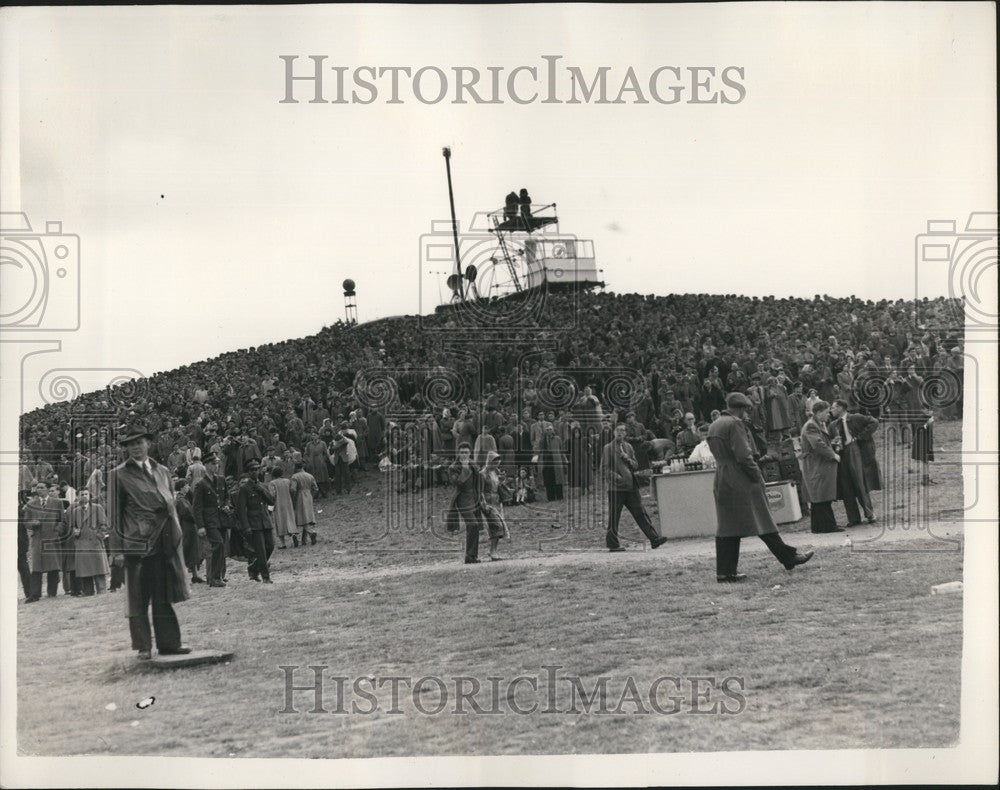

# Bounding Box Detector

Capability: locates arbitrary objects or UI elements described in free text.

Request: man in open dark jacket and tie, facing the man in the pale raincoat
[828,400,882,527]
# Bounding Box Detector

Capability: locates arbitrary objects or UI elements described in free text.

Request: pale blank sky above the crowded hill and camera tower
[0,3,996,407]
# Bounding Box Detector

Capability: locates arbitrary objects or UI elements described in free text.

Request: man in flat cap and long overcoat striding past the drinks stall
[708,392,813,583]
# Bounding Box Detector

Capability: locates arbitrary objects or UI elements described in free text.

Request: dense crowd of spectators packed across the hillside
[19,291,963,601]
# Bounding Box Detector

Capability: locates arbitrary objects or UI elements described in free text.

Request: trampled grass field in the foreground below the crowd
[18,424,962,757]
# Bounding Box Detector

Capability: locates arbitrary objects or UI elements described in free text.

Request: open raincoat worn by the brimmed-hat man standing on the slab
[108,459,191,617]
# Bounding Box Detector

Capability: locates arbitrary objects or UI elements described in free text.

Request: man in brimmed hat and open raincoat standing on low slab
[108,423,191,660]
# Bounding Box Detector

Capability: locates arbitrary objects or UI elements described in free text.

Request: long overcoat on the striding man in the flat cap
[708,411,778,538]
